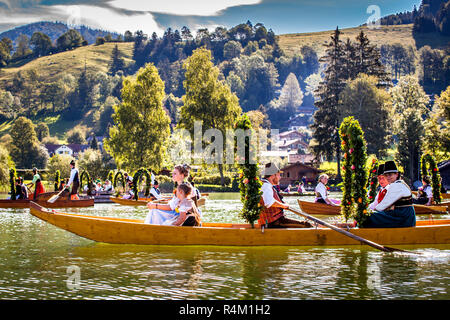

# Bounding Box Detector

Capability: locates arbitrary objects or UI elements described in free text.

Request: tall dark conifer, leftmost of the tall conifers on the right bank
[311,28,346,178]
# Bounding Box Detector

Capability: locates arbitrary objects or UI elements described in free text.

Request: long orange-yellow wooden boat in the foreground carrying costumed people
[30,203,450,246]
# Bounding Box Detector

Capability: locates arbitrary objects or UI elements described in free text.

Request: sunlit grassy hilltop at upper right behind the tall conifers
[278,24,450,57]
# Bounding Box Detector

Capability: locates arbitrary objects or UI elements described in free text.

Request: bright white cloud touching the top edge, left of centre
[109,0,262,16]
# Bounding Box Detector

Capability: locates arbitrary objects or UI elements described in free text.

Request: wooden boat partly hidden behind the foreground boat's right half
[297,200,447,216]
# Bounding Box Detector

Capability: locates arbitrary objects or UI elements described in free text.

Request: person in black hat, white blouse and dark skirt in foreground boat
[360,161,416,228]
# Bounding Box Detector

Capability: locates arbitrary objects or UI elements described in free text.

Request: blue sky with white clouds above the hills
[0,0,421,35]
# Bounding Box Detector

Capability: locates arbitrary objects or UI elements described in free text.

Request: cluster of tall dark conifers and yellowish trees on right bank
[310,29,450,182]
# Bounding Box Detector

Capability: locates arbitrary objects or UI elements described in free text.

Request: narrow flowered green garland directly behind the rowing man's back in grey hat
[235,114,262,228]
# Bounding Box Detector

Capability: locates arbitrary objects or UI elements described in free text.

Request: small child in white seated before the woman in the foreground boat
[145,183,200,226]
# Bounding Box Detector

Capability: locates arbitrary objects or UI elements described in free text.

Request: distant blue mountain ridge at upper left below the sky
[0,21,118,44]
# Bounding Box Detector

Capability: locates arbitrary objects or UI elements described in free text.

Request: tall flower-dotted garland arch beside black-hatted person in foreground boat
[339,117,370,224]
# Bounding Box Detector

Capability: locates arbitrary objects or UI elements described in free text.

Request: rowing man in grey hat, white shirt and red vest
[258,163,311,228]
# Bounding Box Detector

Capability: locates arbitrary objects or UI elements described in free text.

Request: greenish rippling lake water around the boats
[0,194,450,300]
